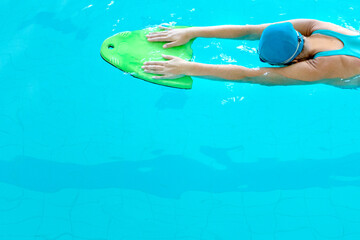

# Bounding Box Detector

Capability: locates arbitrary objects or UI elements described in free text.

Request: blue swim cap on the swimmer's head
[258,22,304,65]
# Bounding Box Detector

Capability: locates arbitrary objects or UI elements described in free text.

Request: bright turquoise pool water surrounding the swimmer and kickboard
[0,0,360,240]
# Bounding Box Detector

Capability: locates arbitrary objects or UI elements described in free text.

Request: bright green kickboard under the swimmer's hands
[100,26,194,89]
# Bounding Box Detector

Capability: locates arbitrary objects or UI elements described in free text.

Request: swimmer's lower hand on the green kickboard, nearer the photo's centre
[141,55,189,79]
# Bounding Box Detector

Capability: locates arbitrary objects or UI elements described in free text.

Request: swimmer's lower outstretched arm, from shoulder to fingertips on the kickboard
[142,55,334,85]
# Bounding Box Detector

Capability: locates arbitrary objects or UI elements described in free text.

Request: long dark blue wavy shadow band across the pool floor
[0,153,360,198]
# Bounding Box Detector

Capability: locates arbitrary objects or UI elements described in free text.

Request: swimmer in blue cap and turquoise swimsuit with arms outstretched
[142,19,360,86]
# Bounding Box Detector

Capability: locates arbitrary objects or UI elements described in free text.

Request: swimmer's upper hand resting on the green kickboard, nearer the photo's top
[146,26,193,48]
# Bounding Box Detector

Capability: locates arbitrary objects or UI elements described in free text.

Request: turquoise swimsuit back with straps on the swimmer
[312,29,360,59]
